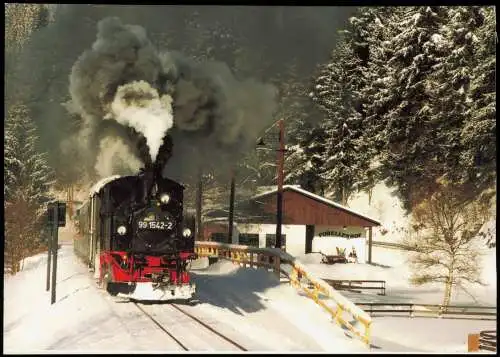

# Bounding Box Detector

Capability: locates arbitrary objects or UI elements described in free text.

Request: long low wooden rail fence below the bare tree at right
[357,302,497,320]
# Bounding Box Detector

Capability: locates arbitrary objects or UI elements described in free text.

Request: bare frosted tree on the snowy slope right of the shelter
[404,181,491,311]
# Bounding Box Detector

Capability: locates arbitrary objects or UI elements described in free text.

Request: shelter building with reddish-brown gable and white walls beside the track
[203,185,381,262]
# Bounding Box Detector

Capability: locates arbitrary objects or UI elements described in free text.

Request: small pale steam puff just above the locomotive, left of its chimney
[94,136,141,177]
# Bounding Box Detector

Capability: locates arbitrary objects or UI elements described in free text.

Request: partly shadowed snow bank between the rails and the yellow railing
[194,260,367,352]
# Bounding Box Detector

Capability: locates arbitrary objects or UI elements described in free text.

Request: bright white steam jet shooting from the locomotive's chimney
[105,81,173,162]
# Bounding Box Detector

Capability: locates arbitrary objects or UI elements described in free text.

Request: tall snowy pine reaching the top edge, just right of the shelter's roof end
[382,7,446,209]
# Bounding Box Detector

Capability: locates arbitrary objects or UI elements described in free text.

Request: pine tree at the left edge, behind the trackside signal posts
[4,104,54,274]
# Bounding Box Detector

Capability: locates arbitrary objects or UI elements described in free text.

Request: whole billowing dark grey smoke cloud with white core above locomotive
[69,18,276,180]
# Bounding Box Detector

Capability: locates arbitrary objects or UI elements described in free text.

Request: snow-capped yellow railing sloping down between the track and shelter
[195,241,372,346]
